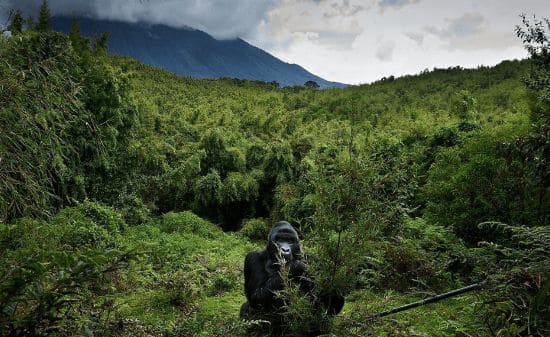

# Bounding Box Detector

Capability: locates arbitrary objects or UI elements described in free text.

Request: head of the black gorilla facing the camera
[267,221,301,262]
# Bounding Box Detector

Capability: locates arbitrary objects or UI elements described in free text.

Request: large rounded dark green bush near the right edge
[423,124,547,243]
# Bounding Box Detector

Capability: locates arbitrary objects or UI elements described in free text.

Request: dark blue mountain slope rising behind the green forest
[53,16,346,88]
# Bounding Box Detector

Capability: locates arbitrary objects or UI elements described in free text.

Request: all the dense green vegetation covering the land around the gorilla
[0,11,550,336]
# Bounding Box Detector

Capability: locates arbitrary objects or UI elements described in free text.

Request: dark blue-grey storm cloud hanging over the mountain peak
[0,0,276,38]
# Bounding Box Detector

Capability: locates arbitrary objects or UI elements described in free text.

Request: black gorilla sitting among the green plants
[241,221,344,318]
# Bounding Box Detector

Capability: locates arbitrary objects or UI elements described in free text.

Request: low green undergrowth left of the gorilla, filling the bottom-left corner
[0,202,251,336]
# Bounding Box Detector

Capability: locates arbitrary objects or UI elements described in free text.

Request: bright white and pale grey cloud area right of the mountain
[254,0,550,83]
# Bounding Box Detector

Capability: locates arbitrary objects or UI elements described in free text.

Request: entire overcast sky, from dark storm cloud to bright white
[0,0,550,84]
